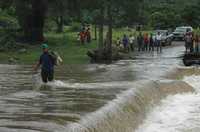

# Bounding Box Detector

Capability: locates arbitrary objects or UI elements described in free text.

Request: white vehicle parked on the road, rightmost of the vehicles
[173,26,193,40]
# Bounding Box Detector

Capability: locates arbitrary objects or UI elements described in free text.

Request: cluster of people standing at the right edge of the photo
[185,32,200,53]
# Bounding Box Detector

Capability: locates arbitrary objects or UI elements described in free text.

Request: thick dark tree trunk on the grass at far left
[16,0,47,42]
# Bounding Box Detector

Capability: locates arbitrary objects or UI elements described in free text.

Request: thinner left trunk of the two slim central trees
[98,7,104,50]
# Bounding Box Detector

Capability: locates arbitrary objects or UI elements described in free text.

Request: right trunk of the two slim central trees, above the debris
[107,4,112,63]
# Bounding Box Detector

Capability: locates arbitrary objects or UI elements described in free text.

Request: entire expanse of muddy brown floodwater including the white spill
[0,43,200,132]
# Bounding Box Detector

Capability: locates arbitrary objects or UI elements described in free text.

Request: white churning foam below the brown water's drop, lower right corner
[136,76,200,132]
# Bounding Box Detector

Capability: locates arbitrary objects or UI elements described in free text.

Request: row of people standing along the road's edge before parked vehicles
[116,32,162,52]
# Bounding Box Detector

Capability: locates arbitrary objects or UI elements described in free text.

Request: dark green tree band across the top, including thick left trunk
[0,0,200,41]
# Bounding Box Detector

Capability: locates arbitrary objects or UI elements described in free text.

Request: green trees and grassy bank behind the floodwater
[0,0,200,64]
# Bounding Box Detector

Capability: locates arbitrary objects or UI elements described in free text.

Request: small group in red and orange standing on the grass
[78,26,91,45]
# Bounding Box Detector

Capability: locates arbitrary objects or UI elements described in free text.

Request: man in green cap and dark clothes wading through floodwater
[34,44,55,83]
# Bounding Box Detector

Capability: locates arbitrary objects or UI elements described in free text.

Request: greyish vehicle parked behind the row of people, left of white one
[154,30,173,46]
